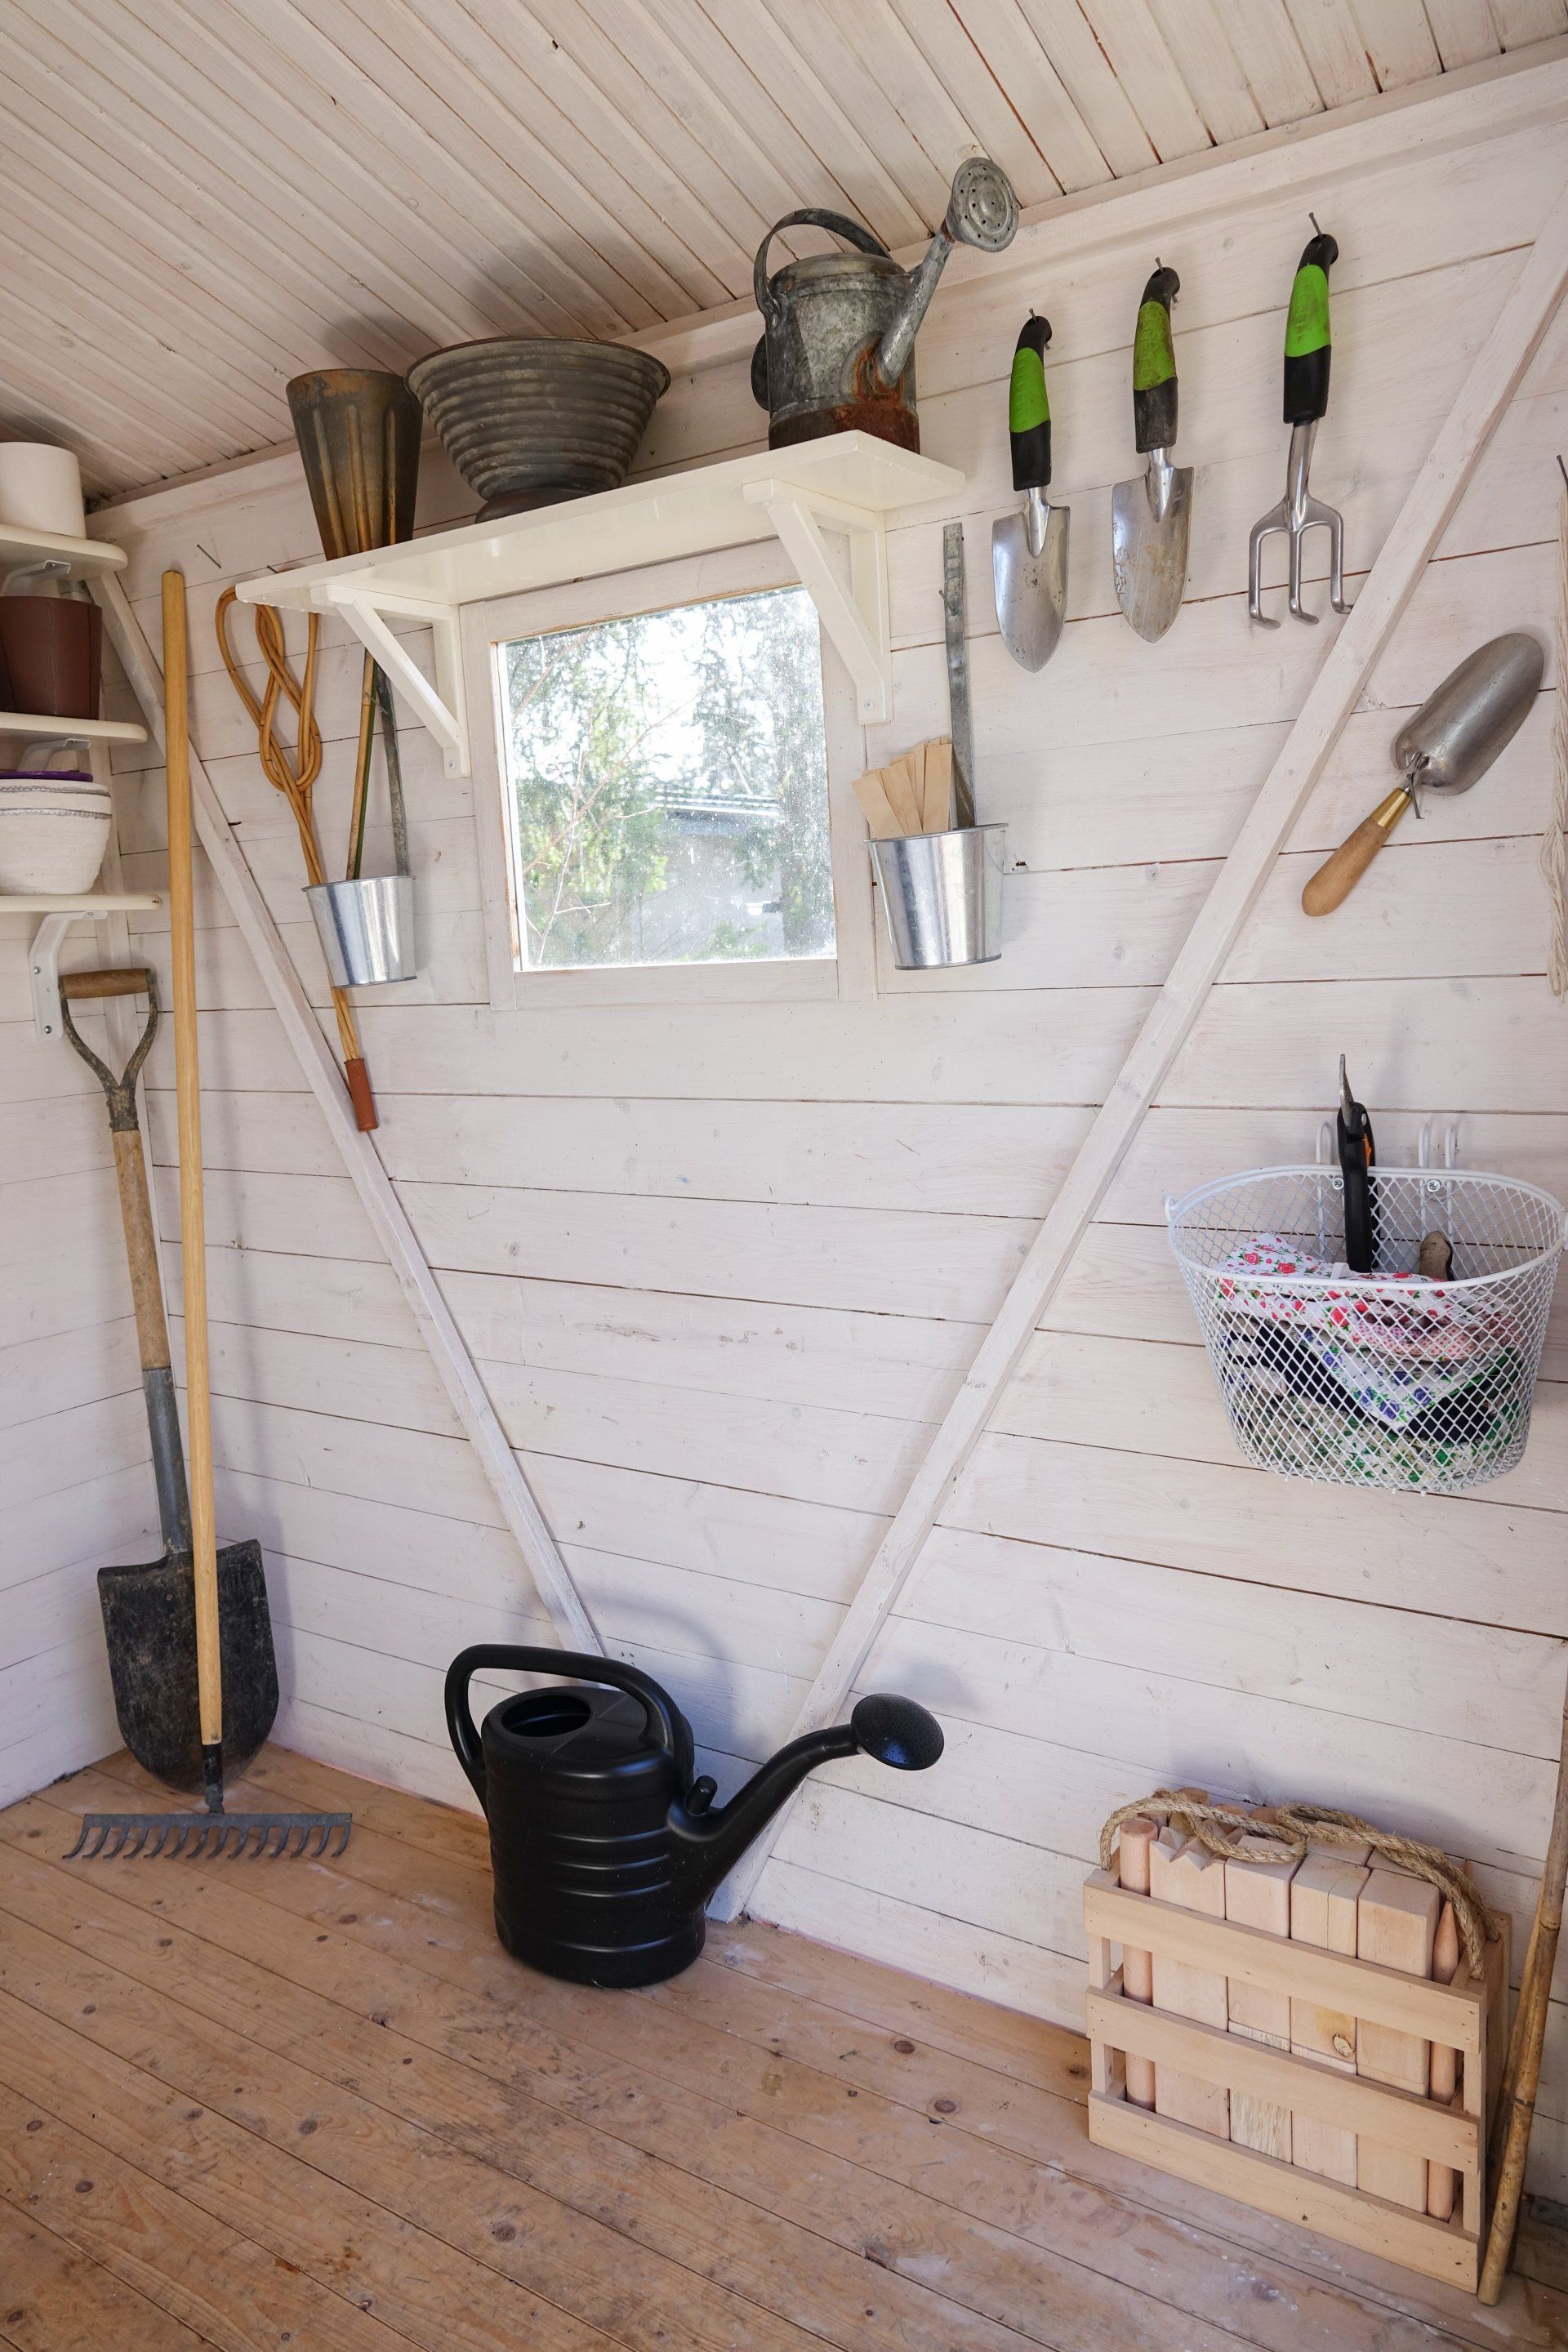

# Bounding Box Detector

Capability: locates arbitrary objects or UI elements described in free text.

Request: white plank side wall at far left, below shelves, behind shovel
[0,936,158,1804]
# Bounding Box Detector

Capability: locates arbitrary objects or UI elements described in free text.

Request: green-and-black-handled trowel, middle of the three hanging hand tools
[1110,268,1192,644]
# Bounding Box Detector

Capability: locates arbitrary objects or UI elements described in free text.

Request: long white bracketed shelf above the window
[237,433,964,776]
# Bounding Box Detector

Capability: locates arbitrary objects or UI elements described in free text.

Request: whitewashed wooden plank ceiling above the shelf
[0,0,1568,494]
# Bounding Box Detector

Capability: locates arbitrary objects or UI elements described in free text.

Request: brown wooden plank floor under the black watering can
[0,1750,1568,2352]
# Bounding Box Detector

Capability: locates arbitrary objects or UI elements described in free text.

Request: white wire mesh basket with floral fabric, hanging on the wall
[1166,1166,1563,1494]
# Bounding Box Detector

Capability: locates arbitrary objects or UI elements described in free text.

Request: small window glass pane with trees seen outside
[496,588,835,971]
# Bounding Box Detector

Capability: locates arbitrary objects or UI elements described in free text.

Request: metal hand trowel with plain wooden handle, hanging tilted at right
[1303,630,1547,915]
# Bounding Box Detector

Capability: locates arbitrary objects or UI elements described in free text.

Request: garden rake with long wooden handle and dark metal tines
[66,572,353,1863]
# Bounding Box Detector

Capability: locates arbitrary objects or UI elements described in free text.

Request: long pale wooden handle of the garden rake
[163,572,223,1768]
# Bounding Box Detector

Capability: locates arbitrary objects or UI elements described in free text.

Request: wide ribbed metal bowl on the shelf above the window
[409,334,670,522]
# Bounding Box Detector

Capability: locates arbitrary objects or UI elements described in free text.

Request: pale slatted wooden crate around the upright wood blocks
[1084,1870,1507,2293]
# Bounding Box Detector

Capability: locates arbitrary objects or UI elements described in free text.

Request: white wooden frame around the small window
[463,539,877,1011]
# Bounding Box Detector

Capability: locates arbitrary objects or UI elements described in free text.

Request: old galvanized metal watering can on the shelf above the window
[752,155,1018,449]
